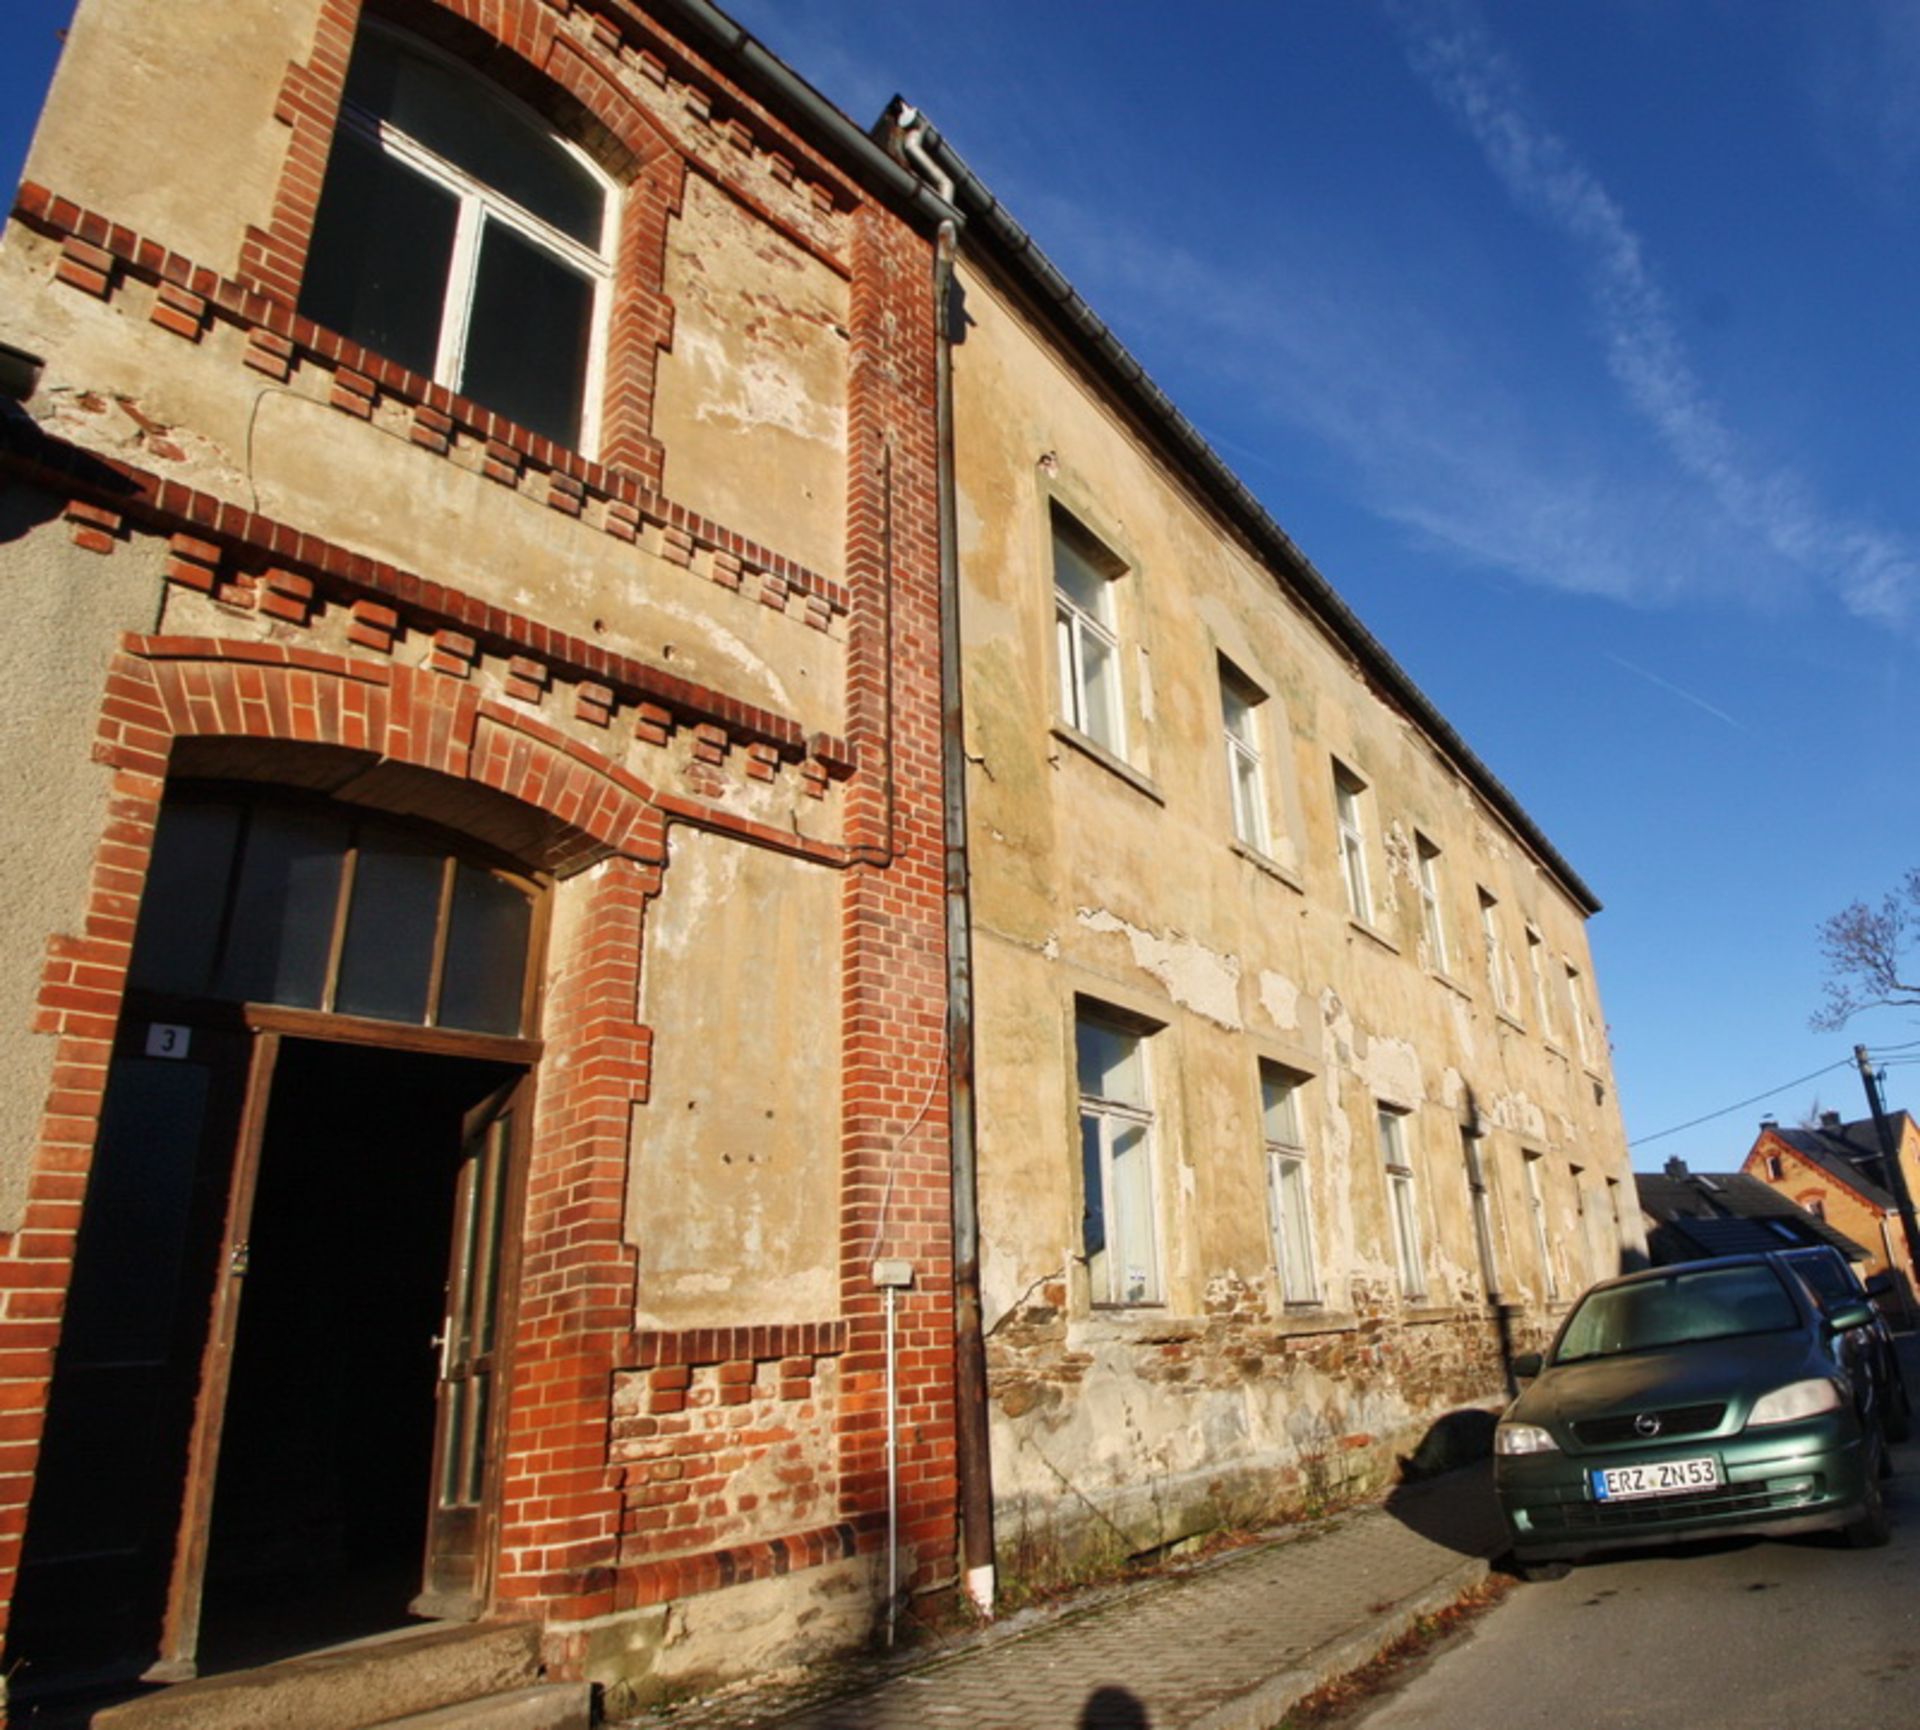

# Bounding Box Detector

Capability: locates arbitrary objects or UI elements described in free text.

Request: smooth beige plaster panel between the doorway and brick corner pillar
[628,829,841,1329]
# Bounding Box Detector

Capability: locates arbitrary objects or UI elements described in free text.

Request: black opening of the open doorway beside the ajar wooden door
[200,1041,516,1674]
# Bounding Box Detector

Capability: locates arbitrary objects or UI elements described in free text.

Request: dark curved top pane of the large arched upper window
[348,31,607,250]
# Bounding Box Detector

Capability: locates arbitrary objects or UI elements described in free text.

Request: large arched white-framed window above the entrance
[300,23,616,451]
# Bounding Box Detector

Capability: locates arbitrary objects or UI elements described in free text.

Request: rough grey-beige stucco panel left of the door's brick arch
[0,486,157,1231]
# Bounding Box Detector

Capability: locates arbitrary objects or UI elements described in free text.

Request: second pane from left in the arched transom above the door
[215,805,348,1010]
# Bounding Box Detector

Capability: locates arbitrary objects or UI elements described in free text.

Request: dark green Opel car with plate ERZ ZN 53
[1494,1256,1889,1574]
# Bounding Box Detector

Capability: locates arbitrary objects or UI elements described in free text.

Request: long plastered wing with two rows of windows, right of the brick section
[883,106,1644,1576]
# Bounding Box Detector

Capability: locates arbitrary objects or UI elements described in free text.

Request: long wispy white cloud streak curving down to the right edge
[1394,0,1920,624]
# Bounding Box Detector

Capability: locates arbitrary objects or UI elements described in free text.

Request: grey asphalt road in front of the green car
[1346,1420,1920,1730]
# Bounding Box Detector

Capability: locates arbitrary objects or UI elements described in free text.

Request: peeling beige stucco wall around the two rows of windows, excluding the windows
[954,257,1644,1553]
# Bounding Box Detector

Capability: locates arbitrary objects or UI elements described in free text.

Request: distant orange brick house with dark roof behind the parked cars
[1740,1112,1920,1310]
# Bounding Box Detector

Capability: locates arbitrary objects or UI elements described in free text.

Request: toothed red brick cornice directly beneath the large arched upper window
[13,180,851,630]
